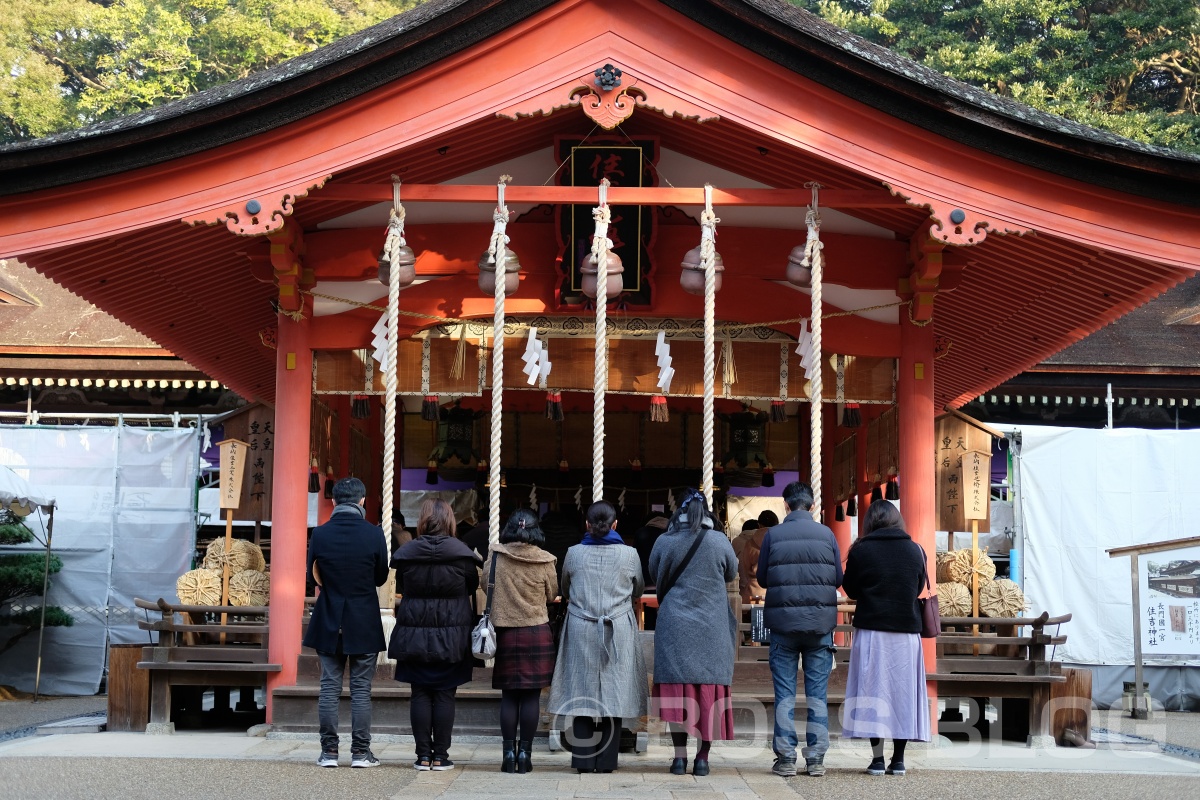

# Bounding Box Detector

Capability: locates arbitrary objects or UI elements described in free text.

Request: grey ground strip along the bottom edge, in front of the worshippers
[0,757,1200,800]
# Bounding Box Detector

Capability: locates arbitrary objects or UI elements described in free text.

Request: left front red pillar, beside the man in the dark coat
[266,314,312,722]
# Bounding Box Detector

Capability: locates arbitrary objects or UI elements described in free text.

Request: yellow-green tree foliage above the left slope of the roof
[0,0,420,142]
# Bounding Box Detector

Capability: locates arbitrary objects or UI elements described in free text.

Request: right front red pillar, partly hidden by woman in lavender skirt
[896,309,937,733]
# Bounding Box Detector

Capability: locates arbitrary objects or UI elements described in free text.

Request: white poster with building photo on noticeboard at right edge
[1138,547,1200,658]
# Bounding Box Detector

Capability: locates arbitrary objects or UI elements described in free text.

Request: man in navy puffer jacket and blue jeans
[757,482,841,777]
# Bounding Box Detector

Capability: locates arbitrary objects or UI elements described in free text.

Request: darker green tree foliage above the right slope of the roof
[791,0,1200,152]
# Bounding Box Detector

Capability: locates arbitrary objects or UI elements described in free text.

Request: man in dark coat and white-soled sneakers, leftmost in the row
[304,477,388,766]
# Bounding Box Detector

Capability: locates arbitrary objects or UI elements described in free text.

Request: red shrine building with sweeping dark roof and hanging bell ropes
[0,0,1200,729]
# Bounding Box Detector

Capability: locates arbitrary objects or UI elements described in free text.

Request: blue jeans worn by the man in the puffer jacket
[770,631,833,760]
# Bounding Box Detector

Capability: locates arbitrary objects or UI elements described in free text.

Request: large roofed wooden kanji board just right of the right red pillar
[934,411,1003,533]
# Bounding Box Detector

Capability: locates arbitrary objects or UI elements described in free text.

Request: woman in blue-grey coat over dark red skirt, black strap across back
[650,489,738,776]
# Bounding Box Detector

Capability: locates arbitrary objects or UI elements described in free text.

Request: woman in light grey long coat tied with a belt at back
[548,500,646,772]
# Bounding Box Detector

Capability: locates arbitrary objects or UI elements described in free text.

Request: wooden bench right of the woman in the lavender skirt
[926,612,1091,746]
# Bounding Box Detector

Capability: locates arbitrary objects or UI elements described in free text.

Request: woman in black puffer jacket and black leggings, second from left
[388,500,479,770]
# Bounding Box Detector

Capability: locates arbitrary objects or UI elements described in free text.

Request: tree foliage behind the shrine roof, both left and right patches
[0,0,1200,152]
